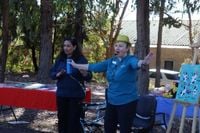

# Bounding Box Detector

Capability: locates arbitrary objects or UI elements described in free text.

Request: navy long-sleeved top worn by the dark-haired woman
[50,56,92,98]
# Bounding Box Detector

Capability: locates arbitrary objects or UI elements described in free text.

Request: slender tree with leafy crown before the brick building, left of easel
[150,0,181,87]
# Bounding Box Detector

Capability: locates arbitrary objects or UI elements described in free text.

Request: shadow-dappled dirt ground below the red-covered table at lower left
[0,108,57,133]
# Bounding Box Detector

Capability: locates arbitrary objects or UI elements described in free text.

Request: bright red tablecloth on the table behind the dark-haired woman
[0,84,91,111]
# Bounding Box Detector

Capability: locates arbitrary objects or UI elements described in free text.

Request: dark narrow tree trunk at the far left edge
[0,0,9,83]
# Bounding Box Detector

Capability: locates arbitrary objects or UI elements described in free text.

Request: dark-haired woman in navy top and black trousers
[50,38,92,133]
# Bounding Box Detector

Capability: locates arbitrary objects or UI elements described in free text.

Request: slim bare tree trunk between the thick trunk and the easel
[155,0,165,87]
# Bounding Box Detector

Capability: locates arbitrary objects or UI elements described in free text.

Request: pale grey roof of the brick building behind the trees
[120,20,200,46]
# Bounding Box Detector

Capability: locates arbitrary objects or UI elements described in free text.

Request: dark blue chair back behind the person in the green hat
[132,95,157,133]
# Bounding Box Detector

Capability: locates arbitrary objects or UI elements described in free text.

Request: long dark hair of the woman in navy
[58,37,83,61]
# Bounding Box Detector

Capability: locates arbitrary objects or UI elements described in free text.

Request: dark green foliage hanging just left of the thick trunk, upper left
[18,0,40,48]
